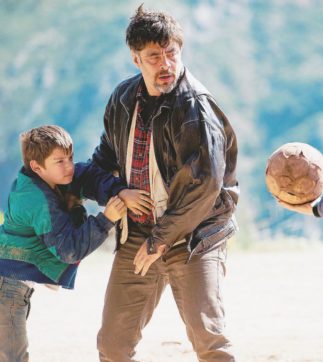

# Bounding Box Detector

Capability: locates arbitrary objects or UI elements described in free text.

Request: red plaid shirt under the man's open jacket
[128,86,154,224]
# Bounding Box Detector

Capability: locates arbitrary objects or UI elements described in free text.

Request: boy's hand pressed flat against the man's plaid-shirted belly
[118,189,154,215]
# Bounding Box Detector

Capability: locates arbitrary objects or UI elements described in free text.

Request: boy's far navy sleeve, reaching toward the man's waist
[68,161,126,206]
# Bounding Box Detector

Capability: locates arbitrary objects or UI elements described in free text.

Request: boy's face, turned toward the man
[30,148,74,188]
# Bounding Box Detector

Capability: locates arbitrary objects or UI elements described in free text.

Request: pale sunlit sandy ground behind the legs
[28,242,323,362]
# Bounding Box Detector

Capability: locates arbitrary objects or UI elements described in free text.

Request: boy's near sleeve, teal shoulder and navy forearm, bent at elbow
[30,193,114,264]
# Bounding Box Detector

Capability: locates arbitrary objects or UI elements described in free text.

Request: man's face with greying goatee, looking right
[131,41,182,96]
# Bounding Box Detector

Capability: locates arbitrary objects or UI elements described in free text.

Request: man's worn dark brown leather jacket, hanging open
[93,69,239,255]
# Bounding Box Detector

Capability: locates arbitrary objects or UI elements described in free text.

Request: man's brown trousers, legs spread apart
[98,224,235,362]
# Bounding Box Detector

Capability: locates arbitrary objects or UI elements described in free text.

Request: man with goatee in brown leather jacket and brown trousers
[93,6,238,362]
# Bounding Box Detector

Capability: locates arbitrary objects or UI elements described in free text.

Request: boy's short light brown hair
[20,125,73,169]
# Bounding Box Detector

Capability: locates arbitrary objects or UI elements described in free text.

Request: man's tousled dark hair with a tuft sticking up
[126,4,184,51]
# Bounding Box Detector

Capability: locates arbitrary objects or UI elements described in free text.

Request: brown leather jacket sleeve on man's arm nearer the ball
[148,94,237,250]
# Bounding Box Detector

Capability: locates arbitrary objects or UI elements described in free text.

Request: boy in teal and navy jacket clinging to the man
[0,126,154,362]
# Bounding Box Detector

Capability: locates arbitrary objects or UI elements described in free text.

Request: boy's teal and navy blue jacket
[0,163,125,288]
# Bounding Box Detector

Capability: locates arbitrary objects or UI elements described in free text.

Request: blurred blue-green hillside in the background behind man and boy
[0,0,323,242]
